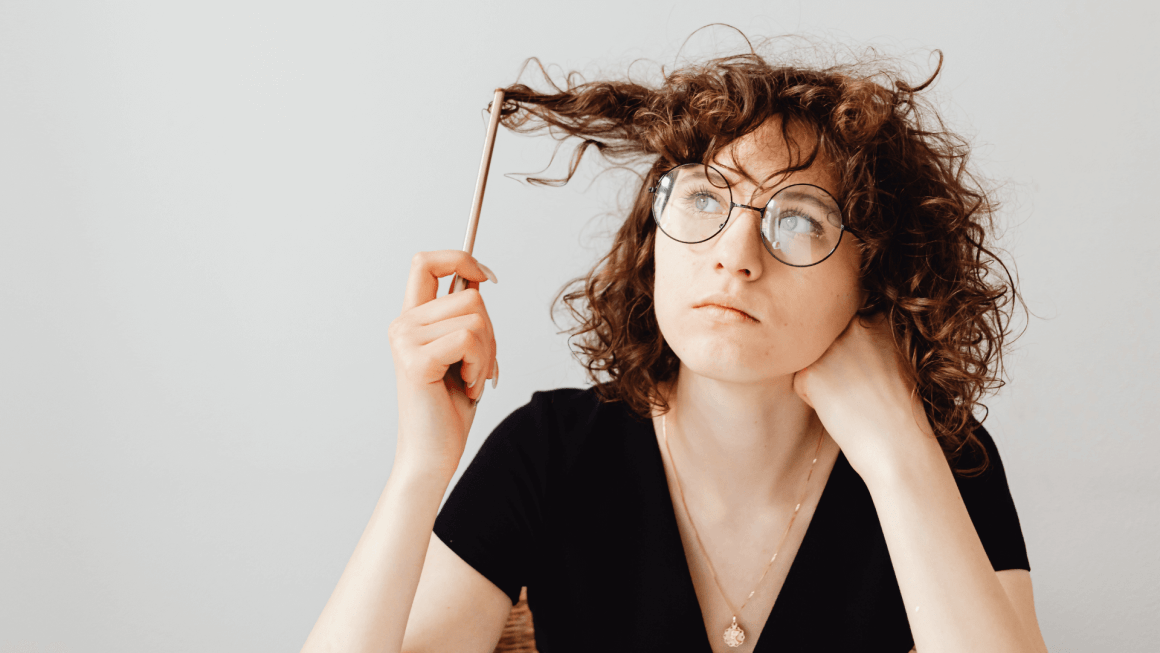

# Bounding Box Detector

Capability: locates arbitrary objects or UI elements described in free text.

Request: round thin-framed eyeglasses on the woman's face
[648,164,849,268]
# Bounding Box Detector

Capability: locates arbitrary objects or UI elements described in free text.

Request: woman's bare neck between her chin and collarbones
[666,365,821,517]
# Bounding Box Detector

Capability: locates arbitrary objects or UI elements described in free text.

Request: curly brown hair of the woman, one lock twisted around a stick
[502,35,1021,476]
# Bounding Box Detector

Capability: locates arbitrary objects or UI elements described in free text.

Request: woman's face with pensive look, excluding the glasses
[654,118,862,383]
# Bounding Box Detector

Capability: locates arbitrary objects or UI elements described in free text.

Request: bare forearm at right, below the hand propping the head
[867,436,1039,653]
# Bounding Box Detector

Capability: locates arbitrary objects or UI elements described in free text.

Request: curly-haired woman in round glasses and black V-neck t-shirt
[304,39,1046,653]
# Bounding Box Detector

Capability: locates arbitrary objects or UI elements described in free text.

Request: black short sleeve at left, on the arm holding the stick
[434,392,556,605]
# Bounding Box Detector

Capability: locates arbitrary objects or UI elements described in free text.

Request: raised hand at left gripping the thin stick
[389,249,499,481]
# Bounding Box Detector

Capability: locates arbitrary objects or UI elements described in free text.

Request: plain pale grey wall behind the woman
[0,0,1160,653]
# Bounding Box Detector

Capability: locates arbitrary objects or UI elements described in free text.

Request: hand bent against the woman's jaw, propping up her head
[793,314,934,478]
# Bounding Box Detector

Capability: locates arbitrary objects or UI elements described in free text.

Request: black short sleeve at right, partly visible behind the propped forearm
[955,426,1031,572]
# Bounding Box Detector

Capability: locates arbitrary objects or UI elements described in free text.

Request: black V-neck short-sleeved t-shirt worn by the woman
[434,389,1031,653]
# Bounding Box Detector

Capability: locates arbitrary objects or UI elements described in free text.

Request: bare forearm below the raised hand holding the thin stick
[303,458,450,653]
